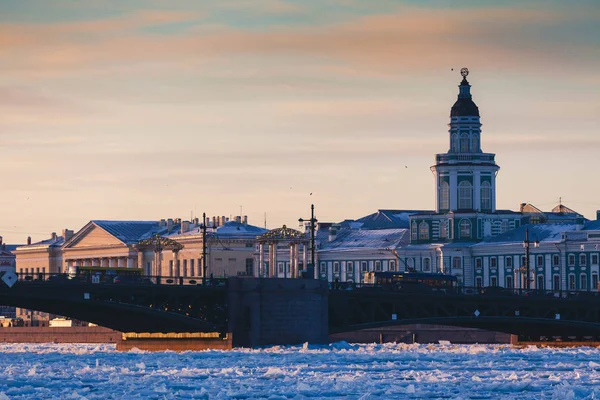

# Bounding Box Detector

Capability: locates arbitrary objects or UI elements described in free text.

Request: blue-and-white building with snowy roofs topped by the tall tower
[310,68,600,290]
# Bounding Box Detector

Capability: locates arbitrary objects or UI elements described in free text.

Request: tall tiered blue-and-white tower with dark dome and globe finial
[431,68,500,214]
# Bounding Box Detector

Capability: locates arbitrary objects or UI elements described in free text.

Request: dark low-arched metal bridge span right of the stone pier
[329,289,600,338]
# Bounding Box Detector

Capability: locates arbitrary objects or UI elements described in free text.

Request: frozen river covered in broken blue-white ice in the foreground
[0,343,600,400]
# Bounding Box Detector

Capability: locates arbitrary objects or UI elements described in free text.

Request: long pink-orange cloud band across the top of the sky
[0,2,591,75]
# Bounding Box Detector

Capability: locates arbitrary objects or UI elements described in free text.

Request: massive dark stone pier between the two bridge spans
[227,278,328,347]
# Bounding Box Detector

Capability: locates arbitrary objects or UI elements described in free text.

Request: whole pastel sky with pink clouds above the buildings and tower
[0,0,600,243]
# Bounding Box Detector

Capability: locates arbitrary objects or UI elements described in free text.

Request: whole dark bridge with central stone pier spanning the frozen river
[0,278,600,346]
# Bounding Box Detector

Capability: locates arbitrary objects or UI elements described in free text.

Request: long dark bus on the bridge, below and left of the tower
[365,271,457,293]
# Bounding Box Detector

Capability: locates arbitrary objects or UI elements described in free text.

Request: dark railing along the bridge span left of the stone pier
[17,271,227,286]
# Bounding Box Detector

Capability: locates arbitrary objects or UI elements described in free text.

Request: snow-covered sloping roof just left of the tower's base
[319,229,409,251]
